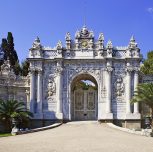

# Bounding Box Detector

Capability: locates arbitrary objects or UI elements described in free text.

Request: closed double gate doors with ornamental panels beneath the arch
[74,89,97,120]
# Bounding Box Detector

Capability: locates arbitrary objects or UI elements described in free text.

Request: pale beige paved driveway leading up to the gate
[0,122,153,152]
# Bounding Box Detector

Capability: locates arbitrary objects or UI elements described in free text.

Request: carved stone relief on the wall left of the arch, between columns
[47,76,56,98]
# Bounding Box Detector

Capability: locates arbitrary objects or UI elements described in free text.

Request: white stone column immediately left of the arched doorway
[56,67,63,119]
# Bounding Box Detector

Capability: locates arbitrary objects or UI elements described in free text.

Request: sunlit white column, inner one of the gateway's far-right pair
[126,67,132,115]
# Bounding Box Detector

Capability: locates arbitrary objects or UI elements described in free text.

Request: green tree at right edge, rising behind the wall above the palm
[141,51,153,74]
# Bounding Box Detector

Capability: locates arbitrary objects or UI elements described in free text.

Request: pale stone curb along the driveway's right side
[107,123,153,137]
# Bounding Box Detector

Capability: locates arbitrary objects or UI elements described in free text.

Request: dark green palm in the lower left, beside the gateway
[0,100,33,131]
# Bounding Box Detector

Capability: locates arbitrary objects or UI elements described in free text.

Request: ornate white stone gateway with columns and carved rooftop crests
[28,27,141,127]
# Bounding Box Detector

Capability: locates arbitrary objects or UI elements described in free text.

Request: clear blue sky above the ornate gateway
[0,0,153,61]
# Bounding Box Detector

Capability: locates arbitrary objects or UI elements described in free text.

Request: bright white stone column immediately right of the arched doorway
[106,67,113,119]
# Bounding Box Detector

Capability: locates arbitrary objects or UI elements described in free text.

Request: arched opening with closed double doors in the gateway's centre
[71,74,98,120]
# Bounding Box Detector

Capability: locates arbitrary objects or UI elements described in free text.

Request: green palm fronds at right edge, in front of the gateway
[131,83,153,125]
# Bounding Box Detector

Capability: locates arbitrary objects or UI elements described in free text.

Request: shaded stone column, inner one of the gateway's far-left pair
[37,70,42,113]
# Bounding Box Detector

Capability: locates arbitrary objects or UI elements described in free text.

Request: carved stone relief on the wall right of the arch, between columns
[114,77,125,97]
